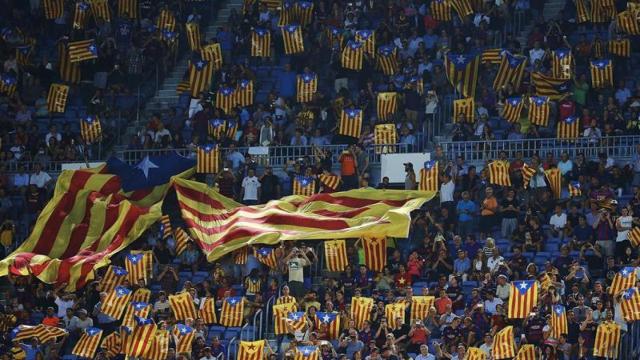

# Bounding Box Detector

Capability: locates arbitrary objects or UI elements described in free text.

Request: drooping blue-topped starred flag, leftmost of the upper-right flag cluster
[444,52,480,98]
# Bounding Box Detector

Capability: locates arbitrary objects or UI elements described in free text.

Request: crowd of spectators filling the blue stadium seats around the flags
[0,0,640,360]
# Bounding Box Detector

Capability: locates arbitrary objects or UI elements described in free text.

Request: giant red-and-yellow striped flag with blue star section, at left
[0,154,195,291]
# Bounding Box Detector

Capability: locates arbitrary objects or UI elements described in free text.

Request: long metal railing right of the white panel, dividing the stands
[439,136,640,162]
